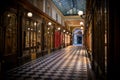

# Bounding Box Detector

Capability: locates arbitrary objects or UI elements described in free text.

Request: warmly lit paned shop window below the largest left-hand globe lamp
[23,18,37,54]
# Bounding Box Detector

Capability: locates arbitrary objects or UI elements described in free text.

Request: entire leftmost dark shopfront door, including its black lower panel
[0,11,18,70]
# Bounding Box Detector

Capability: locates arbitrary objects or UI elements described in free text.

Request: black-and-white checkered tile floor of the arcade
[6,46,93,80]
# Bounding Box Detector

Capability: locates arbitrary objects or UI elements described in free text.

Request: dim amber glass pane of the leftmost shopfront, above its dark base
[4,12,17,55]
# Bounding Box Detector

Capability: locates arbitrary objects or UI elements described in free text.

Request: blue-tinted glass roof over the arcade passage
[52,0,86,16]
